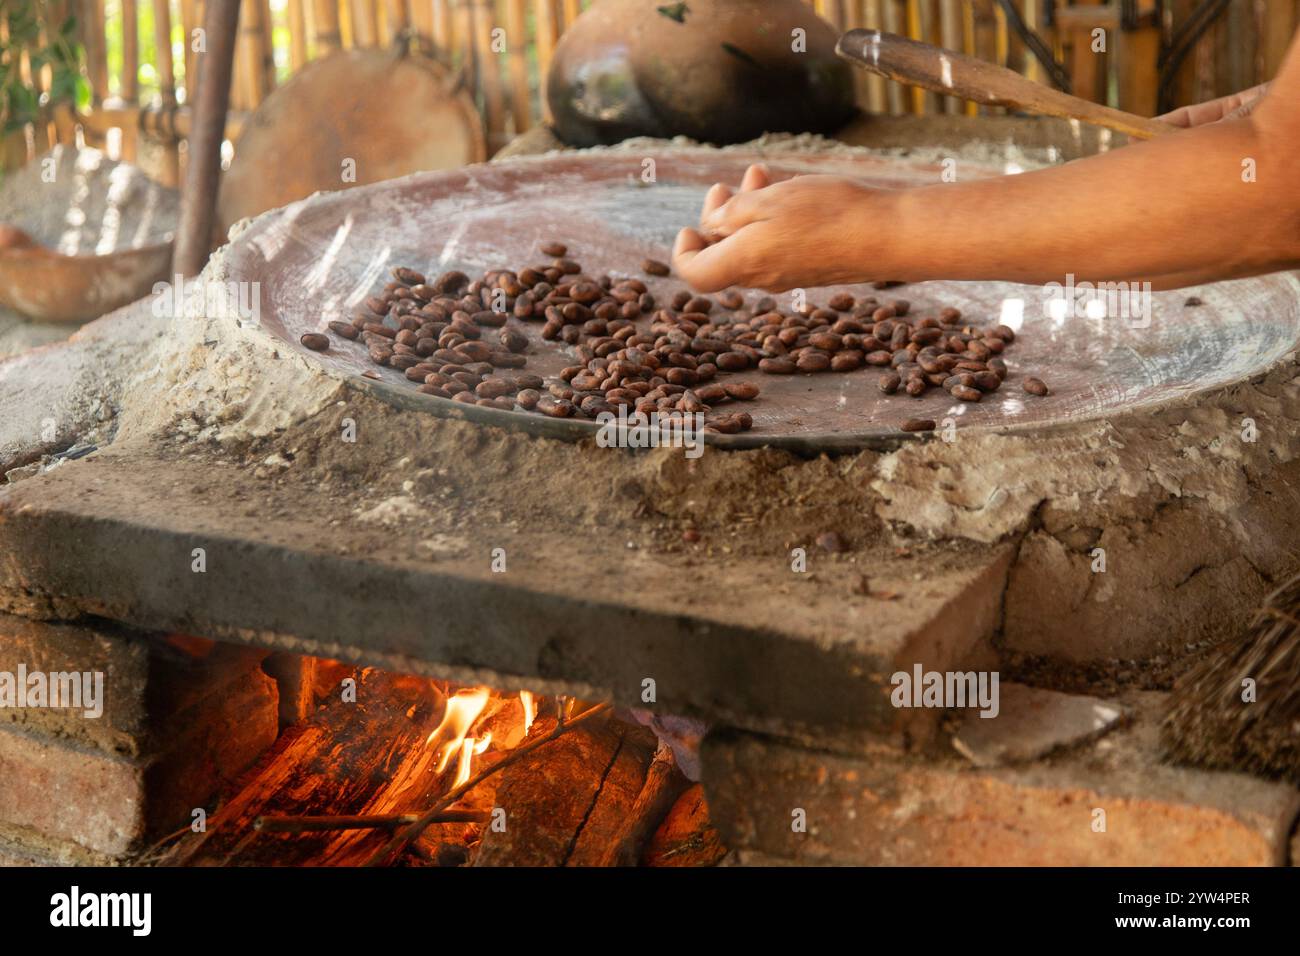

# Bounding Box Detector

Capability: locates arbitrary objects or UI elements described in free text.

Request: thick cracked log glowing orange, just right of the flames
[472,718,655,866]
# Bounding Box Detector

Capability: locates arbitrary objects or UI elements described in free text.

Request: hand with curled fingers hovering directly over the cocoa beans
[672,165,888,293]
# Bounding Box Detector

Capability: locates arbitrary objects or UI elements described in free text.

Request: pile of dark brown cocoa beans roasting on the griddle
[302,242,1048,434]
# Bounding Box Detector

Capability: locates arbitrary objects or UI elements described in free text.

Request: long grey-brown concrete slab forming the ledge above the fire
[0,444,1010,739]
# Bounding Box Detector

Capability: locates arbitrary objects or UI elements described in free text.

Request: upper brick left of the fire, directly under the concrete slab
[0,614,265,756]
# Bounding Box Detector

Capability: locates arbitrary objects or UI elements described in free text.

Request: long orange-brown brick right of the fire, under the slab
[702,693,1300,866]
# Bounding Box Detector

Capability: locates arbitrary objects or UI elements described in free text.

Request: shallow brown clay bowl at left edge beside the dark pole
[0,242,172,323]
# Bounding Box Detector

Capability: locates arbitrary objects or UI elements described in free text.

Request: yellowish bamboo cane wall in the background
[5,0,1300,183]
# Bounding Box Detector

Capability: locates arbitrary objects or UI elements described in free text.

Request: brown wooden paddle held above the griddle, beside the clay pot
[835,30,1178,139]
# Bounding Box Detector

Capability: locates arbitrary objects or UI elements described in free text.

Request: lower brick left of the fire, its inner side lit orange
[0,660,278,857]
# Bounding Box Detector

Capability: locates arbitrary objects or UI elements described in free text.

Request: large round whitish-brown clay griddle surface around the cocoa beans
[228,150,1300,453]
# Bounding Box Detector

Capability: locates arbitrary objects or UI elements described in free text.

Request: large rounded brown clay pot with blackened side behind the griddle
[546,0,854,146]
